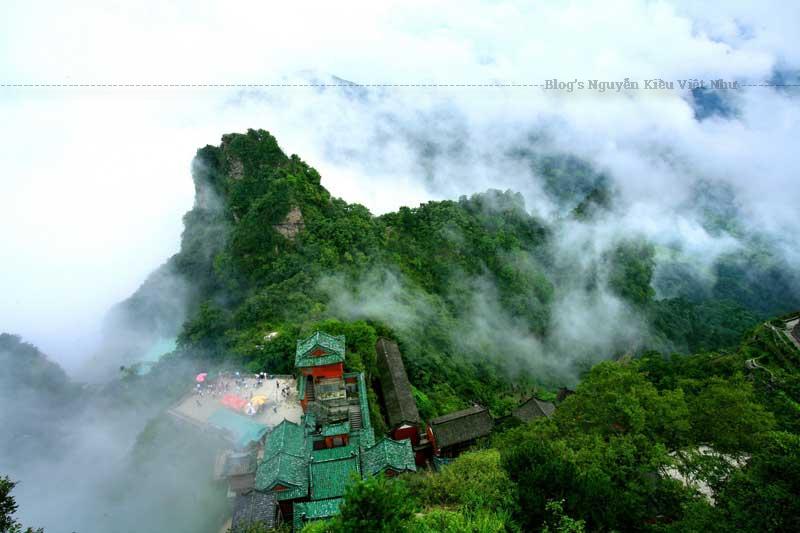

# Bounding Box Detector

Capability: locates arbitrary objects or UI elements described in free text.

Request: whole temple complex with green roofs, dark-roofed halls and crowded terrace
[195,331,555,532]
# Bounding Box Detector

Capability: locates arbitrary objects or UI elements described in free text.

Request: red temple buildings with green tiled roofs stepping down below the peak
[226,332,416,531]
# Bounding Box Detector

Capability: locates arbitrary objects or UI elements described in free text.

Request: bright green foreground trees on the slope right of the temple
[294,321,800,533]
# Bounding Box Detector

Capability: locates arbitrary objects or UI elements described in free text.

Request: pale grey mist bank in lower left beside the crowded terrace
[0,334,226,532]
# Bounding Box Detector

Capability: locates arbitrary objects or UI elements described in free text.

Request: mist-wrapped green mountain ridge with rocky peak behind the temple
[109,130,800,414]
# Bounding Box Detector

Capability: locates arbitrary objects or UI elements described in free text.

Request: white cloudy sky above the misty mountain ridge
[0,0,800,368]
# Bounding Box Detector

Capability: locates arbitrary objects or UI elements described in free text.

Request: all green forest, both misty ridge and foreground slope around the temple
[0,130,800,532]
